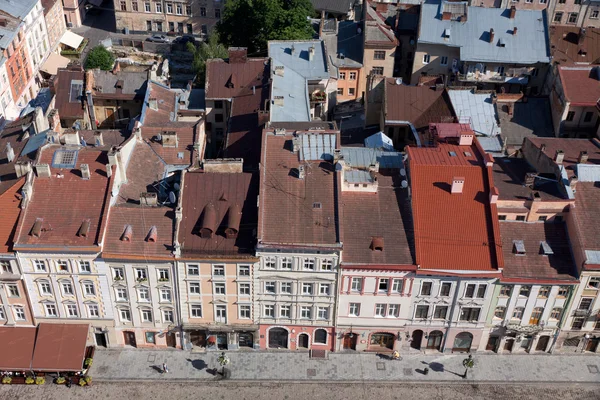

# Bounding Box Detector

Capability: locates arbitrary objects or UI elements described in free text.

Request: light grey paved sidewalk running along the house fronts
[90,349,600,383]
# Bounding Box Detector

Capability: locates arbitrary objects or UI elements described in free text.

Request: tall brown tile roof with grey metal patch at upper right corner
[258,130,339,246]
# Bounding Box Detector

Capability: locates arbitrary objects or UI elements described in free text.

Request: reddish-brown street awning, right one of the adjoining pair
[31,323,89,371]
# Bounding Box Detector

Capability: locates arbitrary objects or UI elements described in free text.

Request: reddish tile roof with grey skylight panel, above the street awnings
[14,145,114,251]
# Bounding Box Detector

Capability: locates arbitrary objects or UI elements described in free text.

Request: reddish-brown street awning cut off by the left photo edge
[0,327,36,371]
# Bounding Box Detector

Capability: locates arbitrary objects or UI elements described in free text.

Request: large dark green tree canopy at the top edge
[217,0,314,54]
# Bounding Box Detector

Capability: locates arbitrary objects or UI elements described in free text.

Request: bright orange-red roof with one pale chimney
[407,144,502,271]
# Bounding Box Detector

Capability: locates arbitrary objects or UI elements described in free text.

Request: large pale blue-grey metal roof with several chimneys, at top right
[419,2,550,64]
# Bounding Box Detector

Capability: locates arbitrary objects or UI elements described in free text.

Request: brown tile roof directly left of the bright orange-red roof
[341,170,414,267]
